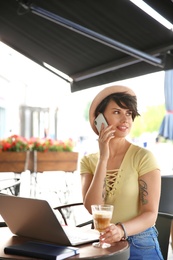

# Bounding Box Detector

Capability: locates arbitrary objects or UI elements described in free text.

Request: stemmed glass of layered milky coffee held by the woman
[91,205,114,248]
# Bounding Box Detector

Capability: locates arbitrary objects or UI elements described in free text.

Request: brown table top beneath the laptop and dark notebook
[0,227,130,260]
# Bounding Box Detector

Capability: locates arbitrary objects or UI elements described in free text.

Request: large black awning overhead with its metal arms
[0,0,173,92]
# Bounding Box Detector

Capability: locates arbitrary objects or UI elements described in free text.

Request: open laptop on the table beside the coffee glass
[0,194,99,246]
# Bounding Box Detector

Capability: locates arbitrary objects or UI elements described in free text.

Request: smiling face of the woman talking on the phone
[104,100,133,137]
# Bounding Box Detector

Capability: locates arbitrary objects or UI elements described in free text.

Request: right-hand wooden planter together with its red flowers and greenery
[29,138,78,172]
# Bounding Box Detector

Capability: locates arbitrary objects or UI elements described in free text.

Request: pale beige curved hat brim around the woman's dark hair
[89,85,136,135]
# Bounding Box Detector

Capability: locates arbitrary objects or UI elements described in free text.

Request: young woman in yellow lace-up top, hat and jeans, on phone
[80,86,163,260]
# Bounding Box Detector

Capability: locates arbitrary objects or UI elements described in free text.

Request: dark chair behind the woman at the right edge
[156,175,173,260]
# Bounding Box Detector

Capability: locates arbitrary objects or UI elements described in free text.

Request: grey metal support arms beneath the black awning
[20,1,164,82]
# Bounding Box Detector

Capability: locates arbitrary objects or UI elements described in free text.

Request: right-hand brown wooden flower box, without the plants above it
[32,151,78,172]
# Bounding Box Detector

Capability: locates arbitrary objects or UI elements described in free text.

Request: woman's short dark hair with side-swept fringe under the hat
[95,92,140,121]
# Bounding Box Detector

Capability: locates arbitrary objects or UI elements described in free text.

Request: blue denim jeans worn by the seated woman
[128,227,164,260]
